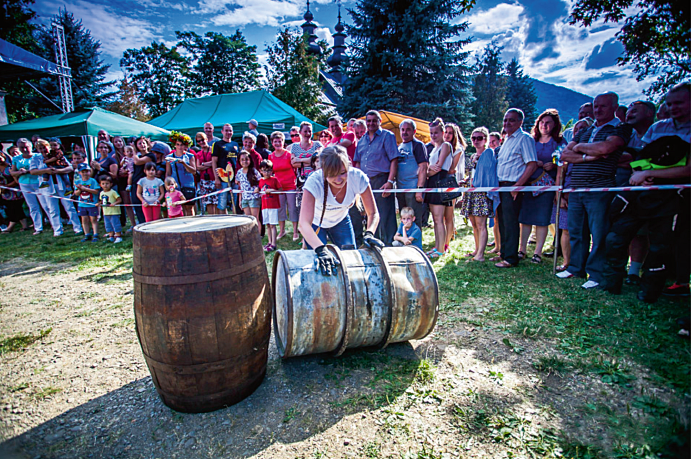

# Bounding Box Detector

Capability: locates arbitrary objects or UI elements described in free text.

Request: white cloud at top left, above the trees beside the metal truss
[38,0,160,59]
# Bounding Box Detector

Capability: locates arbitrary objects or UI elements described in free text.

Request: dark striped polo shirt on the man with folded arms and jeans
[571,118,631,188]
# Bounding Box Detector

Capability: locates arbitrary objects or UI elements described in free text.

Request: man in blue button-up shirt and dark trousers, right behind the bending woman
[353,110,398,245]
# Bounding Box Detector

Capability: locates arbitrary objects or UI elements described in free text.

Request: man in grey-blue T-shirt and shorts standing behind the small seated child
[396,119,429,227]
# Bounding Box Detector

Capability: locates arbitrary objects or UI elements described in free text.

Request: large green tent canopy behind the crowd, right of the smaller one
[149,90,326,138]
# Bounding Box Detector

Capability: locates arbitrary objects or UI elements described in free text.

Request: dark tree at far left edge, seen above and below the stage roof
[0,0,39,123]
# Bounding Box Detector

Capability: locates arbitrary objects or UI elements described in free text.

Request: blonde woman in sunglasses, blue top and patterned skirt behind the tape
[461,126,499,261]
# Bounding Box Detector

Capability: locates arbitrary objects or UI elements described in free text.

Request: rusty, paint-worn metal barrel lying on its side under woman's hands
[272,245,439,358]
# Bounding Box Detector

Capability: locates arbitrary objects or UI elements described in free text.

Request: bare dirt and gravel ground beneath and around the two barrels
[0,261,688,458]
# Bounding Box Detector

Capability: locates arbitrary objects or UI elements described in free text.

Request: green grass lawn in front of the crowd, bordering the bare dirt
[0,218,691,458]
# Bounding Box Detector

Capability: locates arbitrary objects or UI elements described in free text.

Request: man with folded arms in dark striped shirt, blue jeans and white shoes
[557,92,629,289]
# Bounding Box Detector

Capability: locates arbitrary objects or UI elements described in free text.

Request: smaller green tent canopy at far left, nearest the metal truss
[0,107,170,142]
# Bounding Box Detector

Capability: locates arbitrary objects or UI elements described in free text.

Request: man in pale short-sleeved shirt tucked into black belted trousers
[493,108,537,268]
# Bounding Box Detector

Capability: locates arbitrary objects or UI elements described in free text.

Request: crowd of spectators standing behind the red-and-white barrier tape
[0,83,691,302]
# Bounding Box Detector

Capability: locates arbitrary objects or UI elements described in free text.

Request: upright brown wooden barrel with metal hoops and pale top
[133,215,271,413]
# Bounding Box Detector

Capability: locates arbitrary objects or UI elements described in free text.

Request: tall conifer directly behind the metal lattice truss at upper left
[32,9,113,115]
